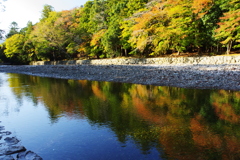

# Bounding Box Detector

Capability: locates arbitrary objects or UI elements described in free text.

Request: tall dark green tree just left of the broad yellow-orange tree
[102,0,147,57]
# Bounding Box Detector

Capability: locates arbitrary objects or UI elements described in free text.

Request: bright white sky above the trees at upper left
[0,0,88,32]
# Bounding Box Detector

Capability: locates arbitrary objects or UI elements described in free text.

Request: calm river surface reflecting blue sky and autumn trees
[0,73,240,160]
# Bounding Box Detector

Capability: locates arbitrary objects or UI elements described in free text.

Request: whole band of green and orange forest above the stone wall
[0,0,240,64]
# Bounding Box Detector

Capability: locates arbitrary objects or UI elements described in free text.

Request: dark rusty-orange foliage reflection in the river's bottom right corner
[190,116,240,160]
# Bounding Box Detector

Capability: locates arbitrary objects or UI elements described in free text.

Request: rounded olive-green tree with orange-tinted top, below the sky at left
[30,9,81,60]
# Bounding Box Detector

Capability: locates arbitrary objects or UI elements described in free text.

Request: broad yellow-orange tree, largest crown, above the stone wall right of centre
[124,0,215,56]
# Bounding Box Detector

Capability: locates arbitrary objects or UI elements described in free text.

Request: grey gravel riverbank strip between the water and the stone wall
[0,64,240,91]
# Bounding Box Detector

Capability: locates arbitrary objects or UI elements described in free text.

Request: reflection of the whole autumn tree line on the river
[3,74,240,159]
